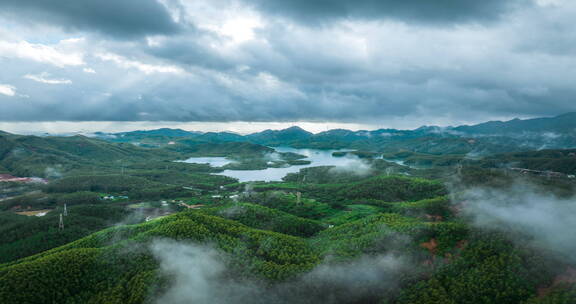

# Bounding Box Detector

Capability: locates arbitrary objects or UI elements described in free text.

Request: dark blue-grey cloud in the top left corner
[0,0,179,37]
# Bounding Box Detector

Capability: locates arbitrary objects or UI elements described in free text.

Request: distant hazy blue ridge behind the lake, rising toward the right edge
[90,113,576,155]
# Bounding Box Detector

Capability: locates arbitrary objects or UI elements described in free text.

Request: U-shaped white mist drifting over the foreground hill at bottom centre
[151,240,414,304]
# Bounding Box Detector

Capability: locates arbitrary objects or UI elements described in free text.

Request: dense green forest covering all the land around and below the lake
[0,129,576,304]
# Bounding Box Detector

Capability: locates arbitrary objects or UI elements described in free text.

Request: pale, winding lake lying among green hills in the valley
[178,147,366,182]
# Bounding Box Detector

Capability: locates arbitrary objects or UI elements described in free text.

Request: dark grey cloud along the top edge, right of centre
[243,0,530,24]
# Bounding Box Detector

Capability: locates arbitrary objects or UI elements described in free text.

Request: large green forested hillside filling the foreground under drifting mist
[0,175,574,304]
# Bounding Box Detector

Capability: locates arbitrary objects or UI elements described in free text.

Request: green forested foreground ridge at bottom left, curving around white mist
[0,211,319,304]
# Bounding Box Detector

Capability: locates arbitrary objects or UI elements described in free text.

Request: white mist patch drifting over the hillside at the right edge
[460,181,576,263]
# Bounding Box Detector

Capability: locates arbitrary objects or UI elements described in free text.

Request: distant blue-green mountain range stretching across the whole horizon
[0,113,576,176]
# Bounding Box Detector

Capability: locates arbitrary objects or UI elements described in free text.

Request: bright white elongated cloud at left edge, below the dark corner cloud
[0,41,84,67]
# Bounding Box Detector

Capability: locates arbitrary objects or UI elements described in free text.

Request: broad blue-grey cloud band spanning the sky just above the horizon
[0,64,574,123]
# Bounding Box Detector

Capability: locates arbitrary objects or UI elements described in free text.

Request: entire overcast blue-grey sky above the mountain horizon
[0,0,576,131]
